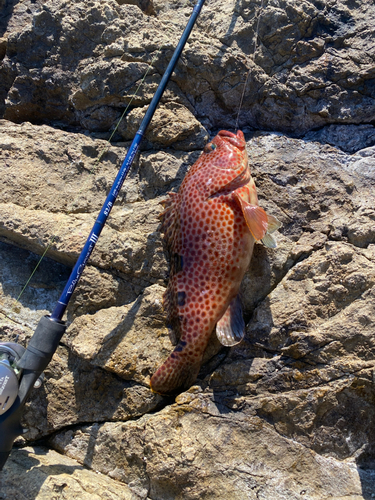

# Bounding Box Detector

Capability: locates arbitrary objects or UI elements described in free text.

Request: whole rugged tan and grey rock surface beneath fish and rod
[0,0,375,500]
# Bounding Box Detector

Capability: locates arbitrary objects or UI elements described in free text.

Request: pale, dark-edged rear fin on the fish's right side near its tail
[216,295,245,346]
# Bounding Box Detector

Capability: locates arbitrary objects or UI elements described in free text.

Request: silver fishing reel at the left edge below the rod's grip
[0,342,43,415]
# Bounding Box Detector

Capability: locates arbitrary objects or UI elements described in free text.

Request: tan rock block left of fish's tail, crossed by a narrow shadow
[65,285,170,387]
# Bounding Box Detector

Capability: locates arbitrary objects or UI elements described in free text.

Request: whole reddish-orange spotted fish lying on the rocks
[150,130,281,394]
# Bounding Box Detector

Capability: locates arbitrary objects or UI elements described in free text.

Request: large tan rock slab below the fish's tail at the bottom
[47,402,373,500]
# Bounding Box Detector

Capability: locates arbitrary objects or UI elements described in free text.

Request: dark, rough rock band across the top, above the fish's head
[0,0,375,133]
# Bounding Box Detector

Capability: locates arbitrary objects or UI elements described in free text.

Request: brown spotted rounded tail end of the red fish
[150,341,202,395]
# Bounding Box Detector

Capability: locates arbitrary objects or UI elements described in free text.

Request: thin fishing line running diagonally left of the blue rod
[0,0,188,324]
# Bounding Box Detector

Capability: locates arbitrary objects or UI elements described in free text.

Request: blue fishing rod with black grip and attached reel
[0,0,205,471]
